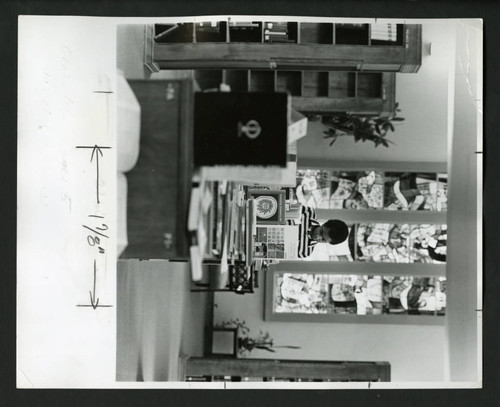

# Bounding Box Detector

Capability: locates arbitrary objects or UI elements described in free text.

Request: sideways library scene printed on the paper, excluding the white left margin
[113,17,481,388]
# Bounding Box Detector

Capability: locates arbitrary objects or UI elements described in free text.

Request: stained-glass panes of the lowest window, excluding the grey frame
[266,271,446,322]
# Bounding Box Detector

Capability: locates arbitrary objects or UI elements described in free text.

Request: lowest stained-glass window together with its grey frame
[264,261,446,325]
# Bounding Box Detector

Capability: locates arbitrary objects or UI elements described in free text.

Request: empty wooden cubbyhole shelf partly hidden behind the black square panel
[195,69,396,115]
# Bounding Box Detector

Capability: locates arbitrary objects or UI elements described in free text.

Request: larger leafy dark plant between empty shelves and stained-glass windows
[322,103,404,147]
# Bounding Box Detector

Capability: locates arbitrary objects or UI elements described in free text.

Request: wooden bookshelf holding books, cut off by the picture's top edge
[146,21,422,73]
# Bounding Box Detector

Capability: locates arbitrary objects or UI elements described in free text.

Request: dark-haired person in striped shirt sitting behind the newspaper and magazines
[288,205,349,258]
